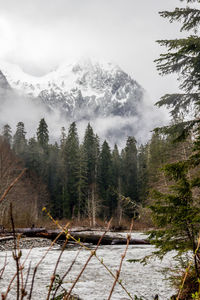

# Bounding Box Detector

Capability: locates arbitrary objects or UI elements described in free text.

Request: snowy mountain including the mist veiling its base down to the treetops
[0,59,161,146]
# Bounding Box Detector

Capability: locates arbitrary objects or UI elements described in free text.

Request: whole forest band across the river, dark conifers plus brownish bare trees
[0,119,191,226]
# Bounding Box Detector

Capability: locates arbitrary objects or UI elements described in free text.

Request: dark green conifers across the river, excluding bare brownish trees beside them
[2,118,146,225]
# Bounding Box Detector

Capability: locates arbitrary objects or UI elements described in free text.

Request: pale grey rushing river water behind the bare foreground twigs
[0,234,174,300]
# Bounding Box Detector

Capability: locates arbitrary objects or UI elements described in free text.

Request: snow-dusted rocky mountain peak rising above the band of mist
[0,59,144,120]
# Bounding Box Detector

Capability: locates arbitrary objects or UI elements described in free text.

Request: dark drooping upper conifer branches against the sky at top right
[156,0,200,138]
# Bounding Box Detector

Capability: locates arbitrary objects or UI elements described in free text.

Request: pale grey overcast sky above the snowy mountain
[0,0,188,102]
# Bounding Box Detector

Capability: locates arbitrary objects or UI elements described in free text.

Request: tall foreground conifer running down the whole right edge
[151,0,200,299]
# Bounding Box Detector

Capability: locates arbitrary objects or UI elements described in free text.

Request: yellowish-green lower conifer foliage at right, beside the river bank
[150,160,200,275]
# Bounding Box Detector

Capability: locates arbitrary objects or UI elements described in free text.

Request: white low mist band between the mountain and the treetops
[0,88,168,148]
